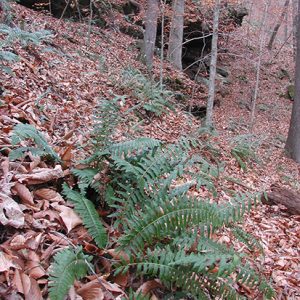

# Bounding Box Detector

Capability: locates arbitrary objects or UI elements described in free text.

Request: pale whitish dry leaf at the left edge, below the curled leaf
[0,192,25,228]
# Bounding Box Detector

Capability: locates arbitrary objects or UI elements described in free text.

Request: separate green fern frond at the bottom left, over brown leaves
[49,247,92,300]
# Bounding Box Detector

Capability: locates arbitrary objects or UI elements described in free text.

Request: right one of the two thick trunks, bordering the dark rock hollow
[168,0,184,70]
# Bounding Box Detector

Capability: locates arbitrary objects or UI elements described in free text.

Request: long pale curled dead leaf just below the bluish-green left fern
[15,165,64,185]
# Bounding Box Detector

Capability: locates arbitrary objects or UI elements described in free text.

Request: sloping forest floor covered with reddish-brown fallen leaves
[0,1,300,299]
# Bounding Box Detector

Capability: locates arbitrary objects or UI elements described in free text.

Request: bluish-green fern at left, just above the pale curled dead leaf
[9,124,60,161]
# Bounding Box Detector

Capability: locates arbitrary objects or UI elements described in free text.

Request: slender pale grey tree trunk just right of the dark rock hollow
[205,0,220,127]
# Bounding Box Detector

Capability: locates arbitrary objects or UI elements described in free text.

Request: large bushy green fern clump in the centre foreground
[52,102,273,299]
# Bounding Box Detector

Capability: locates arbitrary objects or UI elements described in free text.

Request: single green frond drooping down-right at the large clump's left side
[63,184,107,248]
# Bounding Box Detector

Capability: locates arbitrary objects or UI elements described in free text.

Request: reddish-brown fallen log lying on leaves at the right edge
[261,185,300,215]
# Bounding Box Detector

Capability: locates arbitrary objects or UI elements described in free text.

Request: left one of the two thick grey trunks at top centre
[142,0,159,72]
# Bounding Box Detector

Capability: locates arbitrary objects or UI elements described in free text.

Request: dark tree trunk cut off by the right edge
[285,0,300,163]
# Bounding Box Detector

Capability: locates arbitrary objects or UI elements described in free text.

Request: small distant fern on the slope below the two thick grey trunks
[122,68,173,116]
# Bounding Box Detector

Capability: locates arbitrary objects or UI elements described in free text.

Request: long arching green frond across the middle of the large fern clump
[119,197,224,253]
